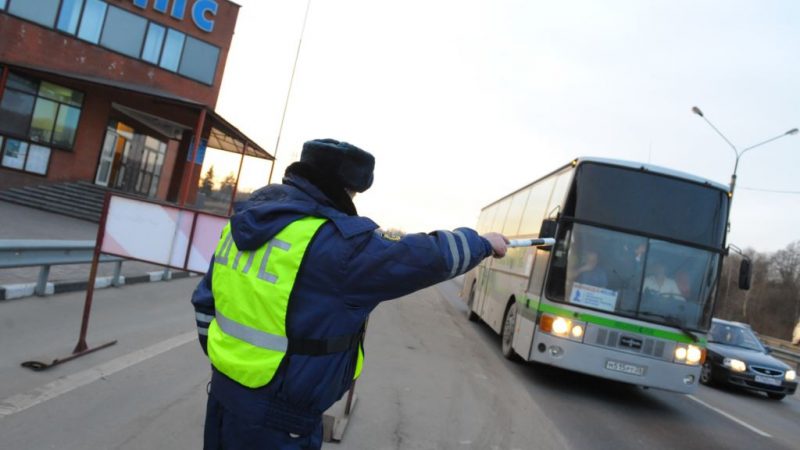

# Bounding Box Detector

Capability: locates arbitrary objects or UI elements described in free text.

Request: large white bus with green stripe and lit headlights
[462,158,730,393]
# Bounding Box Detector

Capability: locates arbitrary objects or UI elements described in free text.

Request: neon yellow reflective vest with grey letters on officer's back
[208,217,363,388]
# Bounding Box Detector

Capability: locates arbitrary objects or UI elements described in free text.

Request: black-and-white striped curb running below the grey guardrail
[0,271,197,301]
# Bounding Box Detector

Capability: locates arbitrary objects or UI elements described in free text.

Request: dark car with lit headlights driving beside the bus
[700,319,797,400]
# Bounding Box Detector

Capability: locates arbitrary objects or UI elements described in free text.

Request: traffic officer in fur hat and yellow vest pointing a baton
[192,139,507,449]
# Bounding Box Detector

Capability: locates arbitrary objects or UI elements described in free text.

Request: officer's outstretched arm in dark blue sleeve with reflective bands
[342,228,493,306]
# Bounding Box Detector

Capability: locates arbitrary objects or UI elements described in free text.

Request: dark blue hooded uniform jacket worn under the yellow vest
[192,175,492,434]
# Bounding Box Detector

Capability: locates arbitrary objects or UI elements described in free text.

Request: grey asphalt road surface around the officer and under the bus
[0,279,800,450]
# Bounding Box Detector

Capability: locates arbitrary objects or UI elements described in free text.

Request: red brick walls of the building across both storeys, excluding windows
[0,0,245,201]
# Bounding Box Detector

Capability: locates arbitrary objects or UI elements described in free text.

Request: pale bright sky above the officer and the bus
[212,0,800,251]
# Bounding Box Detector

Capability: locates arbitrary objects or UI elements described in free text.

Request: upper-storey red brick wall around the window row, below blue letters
[0,0,239,108]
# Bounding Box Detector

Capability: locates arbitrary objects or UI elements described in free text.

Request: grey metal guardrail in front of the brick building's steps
[0,239,124,296]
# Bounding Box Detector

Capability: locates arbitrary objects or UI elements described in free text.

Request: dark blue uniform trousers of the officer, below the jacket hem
[203,393,322,450]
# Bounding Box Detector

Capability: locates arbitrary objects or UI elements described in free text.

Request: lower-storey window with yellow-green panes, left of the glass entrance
[0,73,83,149]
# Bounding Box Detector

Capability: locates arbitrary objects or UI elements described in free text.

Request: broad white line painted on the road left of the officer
[0,331,197,419]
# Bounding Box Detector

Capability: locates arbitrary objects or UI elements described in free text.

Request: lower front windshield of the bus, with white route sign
[547,223,719,331]
